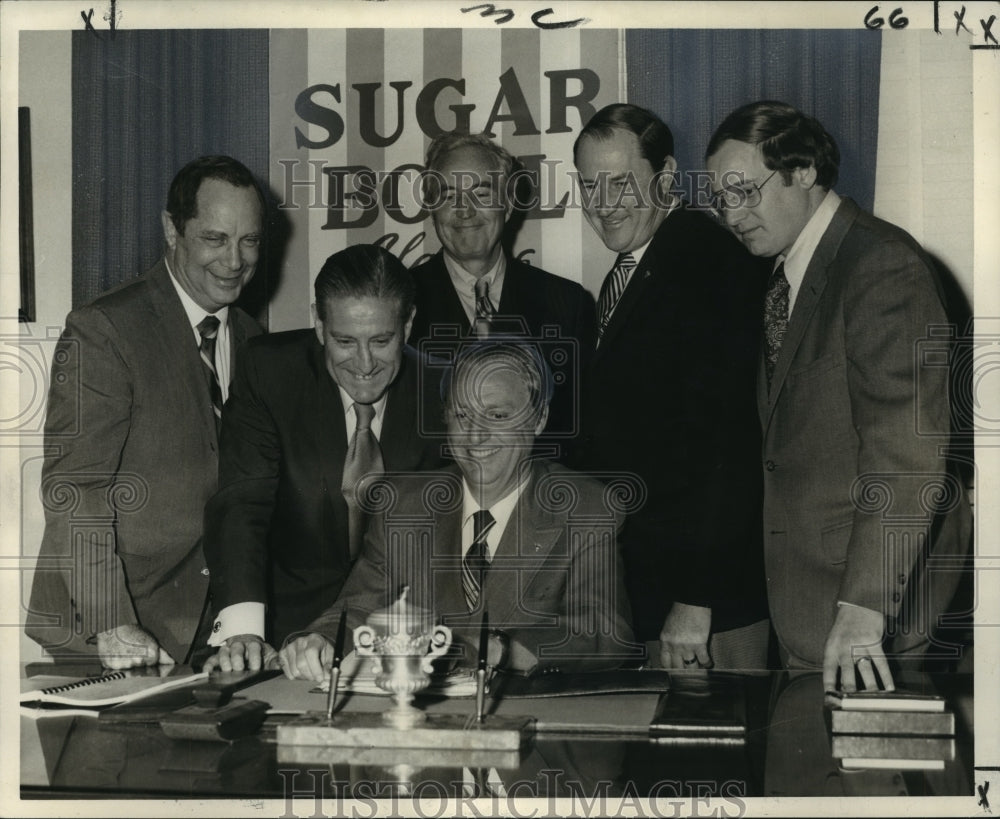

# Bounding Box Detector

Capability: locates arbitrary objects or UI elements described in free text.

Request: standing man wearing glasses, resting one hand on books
[707,102,970,690]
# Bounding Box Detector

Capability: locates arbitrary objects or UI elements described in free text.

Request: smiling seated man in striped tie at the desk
[280,339,634,680]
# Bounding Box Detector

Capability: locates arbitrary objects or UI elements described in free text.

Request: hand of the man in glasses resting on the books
[823,605,896,691]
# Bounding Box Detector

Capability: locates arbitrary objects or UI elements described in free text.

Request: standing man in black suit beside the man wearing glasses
[574,104,768,668]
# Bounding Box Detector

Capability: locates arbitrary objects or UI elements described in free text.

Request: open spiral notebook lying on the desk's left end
[20,669,208,713]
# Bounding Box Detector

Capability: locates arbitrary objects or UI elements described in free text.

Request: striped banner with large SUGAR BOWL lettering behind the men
[269,29,624,331]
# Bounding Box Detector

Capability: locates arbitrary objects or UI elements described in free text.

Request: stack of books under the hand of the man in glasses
[830,691,955,770]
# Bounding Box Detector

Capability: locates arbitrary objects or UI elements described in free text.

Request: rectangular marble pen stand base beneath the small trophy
[278,711,535,751]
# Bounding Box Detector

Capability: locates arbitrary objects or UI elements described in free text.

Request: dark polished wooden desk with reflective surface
[21,672,973,800]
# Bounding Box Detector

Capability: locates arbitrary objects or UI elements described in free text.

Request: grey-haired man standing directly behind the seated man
[411,134,596,459]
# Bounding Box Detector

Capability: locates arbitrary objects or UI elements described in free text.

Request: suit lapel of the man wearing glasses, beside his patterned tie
[758,199,858,424]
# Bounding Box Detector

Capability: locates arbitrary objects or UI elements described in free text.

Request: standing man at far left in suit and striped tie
[26,156,263,668]
